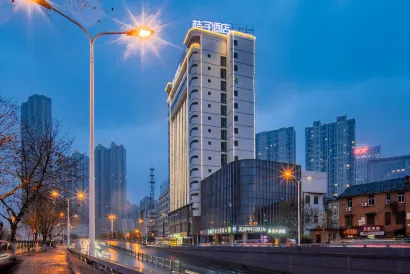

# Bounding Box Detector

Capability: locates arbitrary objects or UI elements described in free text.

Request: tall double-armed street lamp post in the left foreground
[31,0,154,255]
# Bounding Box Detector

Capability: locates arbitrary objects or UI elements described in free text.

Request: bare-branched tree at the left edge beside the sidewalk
[0,108,78,253]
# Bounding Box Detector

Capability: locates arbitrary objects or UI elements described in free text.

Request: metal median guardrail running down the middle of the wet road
[106,243,218,274]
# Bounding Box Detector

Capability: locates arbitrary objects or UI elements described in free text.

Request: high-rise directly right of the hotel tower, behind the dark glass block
[255,127,296,164]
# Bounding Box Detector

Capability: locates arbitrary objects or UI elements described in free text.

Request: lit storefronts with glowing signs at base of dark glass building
[200,225,288,245]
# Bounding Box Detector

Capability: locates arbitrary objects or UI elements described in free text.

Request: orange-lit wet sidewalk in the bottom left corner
[13,246,71,274]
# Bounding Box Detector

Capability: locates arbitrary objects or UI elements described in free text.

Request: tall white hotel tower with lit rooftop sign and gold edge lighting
[165,21,255,235]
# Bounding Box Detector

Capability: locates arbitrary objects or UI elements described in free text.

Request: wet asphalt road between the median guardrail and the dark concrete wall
[108,241,272,274]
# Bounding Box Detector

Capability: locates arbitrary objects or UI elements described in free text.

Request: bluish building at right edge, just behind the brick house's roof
[367,155,410,183]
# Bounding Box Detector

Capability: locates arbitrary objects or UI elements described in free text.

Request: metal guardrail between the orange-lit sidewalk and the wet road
[67,248,142,274]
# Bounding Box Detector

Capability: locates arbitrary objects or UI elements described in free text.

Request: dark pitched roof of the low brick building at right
[339,176,410,198]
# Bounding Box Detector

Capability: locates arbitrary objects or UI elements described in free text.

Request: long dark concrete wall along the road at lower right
[161,247,410,274]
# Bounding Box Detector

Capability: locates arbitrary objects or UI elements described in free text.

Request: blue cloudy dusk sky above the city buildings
[0,0,410,202]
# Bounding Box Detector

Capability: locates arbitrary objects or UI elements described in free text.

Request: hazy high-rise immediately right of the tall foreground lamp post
[95,142,127,233]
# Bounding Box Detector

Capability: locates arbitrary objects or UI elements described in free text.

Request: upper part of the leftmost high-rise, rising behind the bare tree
[21,94,52,140]
